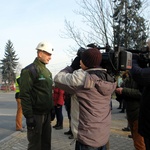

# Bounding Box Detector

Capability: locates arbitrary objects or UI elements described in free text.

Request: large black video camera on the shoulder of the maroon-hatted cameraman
[77,43,132,76]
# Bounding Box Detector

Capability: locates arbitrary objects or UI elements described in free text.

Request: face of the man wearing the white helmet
[38,51,52,64]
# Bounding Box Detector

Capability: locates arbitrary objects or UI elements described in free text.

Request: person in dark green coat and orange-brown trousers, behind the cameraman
[116,71,146,150]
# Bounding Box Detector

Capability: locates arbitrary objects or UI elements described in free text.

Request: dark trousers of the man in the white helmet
[27,114,51,150]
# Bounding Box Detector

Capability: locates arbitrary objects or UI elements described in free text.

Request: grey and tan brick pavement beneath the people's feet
[0,100,135,150]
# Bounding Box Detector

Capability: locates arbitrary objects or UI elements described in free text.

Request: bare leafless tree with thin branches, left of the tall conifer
[63,0,113,46]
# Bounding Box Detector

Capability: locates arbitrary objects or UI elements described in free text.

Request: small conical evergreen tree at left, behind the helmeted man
[0,40,19,87]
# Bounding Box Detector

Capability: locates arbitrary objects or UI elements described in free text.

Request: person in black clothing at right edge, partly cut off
[131,39,150,150]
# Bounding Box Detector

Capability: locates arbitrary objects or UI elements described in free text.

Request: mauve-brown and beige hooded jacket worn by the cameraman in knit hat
[54,67,116,147]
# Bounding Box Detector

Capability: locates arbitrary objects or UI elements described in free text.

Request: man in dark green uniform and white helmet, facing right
[20,42,53,150]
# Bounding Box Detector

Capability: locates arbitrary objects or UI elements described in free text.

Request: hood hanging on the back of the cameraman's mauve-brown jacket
[84,70,117,96]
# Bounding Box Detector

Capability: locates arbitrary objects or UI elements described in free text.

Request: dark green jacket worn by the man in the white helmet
[20,58,53,118]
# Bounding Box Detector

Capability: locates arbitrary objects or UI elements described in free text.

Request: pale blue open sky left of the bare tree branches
[0,0,82,75]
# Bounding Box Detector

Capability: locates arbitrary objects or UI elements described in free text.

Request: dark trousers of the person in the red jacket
[55,106,63,126]
